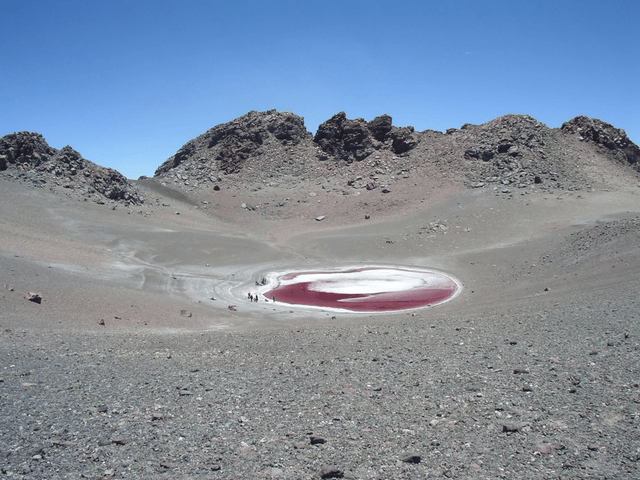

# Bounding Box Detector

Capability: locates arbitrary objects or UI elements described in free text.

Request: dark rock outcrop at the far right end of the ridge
[560,115,640,171]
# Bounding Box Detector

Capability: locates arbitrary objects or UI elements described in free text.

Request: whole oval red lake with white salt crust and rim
[258,266,462,313]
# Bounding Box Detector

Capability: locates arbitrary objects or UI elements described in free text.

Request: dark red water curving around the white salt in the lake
[264,272,457,312]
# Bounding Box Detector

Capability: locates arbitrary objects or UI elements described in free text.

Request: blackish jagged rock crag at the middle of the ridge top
[313,112,418,163]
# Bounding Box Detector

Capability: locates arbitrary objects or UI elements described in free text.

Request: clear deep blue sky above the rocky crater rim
[0,0,640,178]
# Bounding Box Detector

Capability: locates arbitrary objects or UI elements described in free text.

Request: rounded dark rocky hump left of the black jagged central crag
[155,110,311,176]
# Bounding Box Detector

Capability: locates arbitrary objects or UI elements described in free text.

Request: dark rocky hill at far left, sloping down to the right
[0,132,144,205]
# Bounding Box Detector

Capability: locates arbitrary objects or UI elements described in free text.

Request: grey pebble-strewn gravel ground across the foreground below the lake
[0,289,640,479]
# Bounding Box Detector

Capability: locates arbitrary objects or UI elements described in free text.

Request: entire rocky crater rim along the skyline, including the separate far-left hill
[0,110,640,212]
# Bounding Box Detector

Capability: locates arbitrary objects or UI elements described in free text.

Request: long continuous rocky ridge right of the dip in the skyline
[155,110,640,193]
